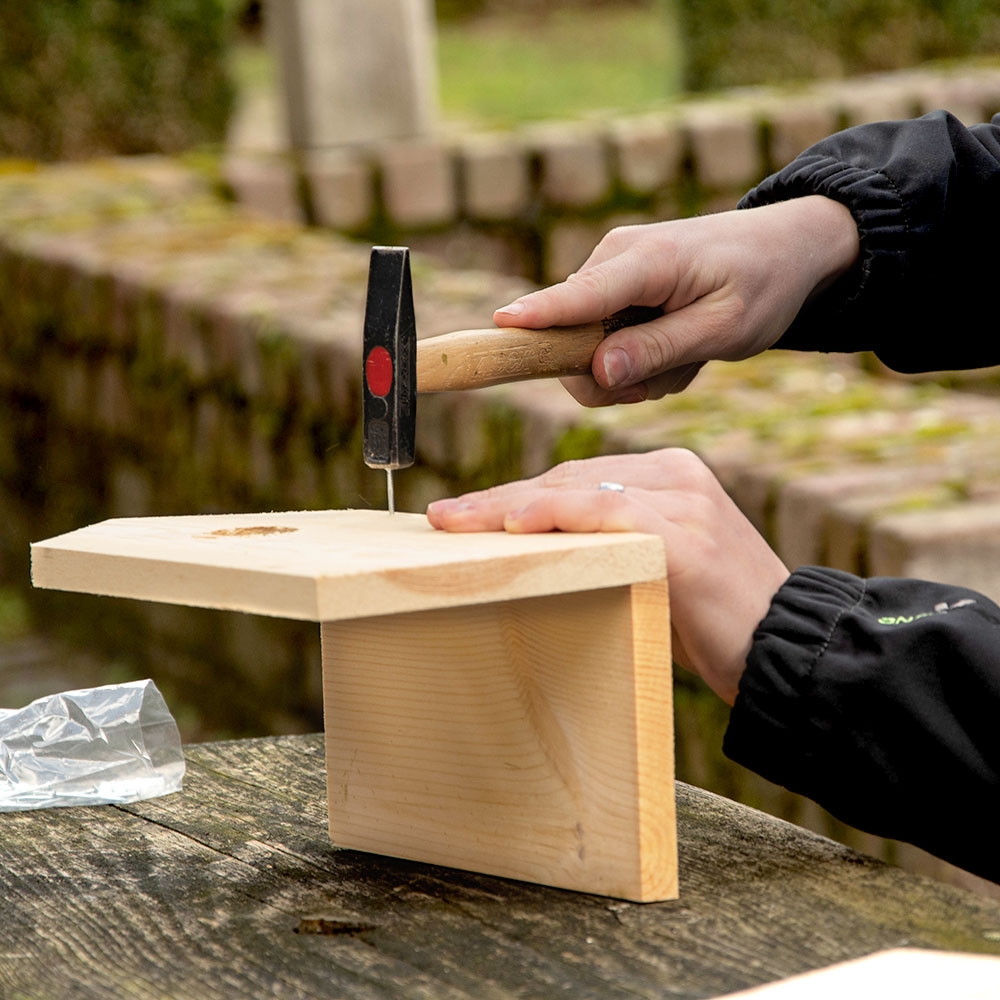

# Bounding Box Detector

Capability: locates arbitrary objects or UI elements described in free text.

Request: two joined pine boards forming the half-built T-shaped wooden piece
[32,511,677,901]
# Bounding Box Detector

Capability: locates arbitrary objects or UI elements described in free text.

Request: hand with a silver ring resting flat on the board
[427,448,788,705]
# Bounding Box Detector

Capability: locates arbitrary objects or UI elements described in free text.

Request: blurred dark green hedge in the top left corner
[0,0,233,160]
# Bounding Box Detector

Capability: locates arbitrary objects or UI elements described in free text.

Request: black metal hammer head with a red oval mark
[362,247,417,469]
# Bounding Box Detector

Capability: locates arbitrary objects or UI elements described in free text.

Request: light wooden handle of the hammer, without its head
[417,306,662,392]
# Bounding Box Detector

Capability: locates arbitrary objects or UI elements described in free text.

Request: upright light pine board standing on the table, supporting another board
[322,581,677,900]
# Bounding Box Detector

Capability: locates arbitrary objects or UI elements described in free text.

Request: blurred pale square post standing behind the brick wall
[267,0,437,150]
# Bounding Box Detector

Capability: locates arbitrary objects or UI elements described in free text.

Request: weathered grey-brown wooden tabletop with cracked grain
[0,736,1000,1000]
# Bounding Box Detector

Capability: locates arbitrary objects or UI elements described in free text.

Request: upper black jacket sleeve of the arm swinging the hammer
[740,111,1000,372]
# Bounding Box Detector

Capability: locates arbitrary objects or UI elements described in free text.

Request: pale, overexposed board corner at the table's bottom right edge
[725,948,1000,1000]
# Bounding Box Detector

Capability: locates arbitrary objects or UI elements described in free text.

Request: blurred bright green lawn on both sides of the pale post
[232,0,681,129]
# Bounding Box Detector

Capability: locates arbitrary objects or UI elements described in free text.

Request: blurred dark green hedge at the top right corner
[676,0,1000,90]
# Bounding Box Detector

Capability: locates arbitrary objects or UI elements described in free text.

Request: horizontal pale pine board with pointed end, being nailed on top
[31,510,666,621]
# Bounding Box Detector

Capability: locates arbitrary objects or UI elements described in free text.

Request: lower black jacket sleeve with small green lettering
[724,567,1000,881]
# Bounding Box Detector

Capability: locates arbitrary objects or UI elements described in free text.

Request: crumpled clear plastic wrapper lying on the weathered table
[0,680,184,812]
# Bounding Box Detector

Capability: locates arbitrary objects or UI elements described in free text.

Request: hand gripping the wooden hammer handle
[493,195,858,406]
